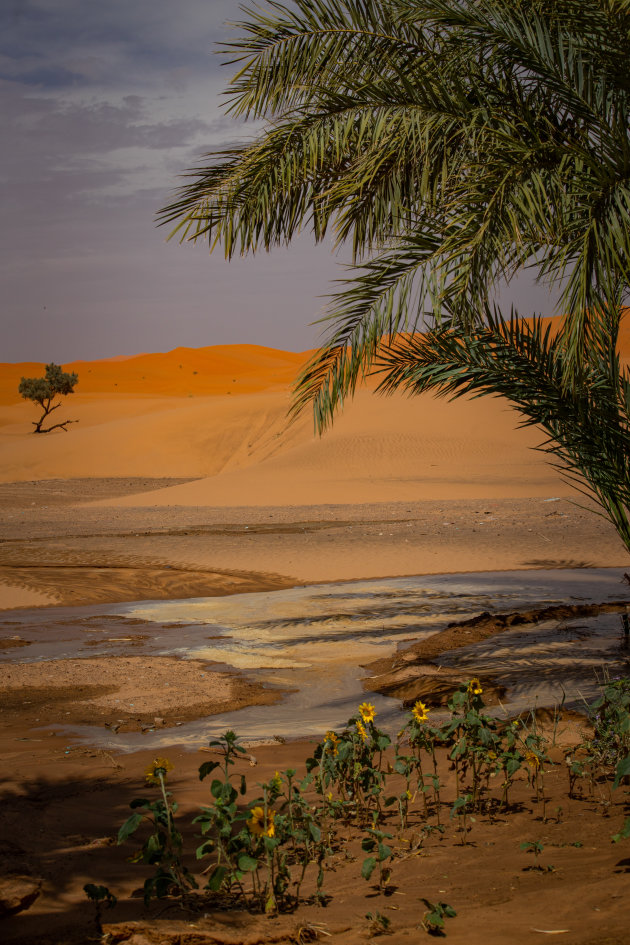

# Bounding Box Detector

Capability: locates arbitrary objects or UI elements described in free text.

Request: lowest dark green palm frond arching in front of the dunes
[374,309,630,550]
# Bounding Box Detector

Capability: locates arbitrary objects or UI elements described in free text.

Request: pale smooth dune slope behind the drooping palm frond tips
[98,391,571,506]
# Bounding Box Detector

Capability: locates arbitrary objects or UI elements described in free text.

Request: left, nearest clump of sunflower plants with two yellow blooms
[118,731,331,914]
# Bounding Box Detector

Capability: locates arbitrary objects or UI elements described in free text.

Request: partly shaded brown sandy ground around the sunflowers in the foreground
[2,716,629,945]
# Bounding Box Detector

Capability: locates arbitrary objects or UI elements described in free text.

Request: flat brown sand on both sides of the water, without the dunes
[0,481,628,945]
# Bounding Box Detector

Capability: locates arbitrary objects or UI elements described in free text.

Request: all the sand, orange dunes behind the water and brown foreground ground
[0,341,628,945]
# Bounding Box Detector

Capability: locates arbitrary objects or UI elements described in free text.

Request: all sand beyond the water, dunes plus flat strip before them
[0,336,625,607]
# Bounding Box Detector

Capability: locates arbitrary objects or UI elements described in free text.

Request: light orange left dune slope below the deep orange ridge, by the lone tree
[0,392,311,482]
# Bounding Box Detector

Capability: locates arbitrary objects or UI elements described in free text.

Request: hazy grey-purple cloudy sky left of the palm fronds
[0,0,560,364]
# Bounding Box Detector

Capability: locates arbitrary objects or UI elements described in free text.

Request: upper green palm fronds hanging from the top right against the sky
[159,0,630,544]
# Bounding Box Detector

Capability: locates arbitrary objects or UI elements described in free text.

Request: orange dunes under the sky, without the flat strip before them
[0,318,630,506]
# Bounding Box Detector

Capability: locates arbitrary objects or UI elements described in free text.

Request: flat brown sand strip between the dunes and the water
[0,479,627,608]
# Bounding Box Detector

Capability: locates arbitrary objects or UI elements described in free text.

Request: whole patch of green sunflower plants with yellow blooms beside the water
[106,678,630,924]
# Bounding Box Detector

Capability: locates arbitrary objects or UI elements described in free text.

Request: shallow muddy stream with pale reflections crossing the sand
[0,569,629,750]
